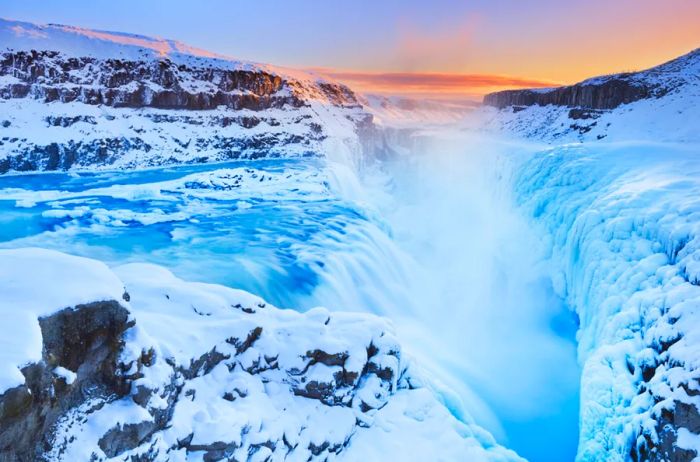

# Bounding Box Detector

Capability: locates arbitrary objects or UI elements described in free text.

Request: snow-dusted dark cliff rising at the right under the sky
[479,49,700,143]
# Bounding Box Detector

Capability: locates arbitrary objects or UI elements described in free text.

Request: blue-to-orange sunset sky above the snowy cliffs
[0,0,700,96]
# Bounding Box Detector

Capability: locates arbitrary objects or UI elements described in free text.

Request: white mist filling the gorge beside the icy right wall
[314,130,579,461]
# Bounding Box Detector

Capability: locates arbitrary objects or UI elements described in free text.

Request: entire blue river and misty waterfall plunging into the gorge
[0,140,578,461]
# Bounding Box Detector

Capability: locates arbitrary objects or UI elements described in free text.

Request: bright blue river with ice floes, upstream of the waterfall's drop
[0,160,394,310]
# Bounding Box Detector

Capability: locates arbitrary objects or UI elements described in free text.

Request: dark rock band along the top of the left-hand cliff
[0,50,358,110]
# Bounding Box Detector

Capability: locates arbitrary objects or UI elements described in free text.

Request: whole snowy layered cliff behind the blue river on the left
[0,20,372,173]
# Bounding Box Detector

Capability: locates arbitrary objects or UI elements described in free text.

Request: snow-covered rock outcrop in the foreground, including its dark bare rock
[0,249,521,462]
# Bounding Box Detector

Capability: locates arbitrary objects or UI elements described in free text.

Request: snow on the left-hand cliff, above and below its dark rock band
[0,19,369,174]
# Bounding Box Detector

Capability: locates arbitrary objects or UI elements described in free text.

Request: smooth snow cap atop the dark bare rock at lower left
[0,248,124,393]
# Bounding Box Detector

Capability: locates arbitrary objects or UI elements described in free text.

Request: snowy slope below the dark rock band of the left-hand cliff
[0,98,362,170]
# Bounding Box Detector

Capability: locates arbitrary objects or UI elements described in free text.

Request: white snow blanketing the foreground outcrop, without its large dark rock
[0,249,522,461]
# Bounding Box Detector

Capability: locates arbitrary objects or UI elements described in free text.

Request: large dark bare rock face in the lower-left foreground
[0,301,130,462]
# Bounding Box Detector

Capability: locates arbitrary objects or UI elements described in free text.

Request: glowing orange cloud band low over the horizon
[314,69,557,97]
